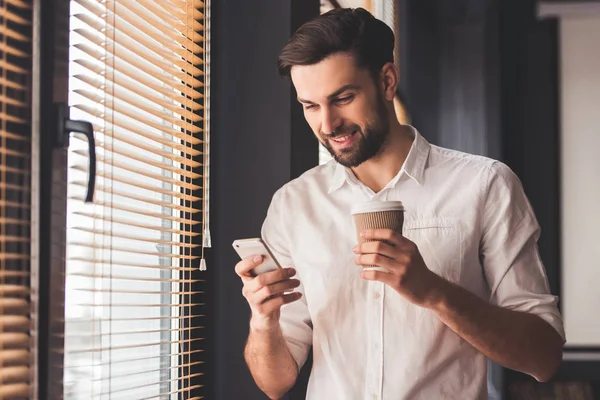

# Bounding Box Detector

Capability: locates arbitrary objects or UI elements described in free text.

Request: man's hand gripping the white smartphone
[235,255,302,330]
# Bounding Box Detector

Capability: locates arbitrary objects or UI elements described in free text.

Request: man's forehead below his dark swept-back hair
[291,53,370,102]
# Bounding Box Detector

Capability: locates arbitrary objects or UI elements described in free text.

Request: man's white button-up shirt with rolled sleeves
[262,128,564,400]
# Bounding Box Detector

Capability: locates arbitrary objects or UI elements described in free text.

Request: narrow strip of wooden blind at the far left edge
[0,0,34,399]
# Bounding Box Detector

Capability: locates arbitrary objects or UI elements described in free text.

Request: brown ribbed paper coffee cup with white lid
[351,201,404,272]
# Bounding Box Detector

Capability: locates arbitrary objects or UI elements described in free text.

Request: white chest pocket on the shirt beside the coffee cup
[402,218,463,283]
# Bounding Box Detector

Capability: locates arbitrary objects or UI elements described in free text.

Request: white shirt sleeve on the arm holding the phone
[262,188,312,369]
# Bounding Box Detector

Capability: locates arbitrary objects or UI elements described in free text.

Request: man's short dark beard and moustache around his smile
[321,96,390,168]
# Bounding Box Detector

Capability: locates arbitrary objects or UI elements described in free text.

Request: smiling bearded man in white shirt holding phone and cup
[236,9,564,400]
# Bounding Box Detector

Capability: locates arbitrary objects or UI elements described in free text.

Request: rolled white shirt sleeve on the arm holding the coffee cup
[481,162,565,342]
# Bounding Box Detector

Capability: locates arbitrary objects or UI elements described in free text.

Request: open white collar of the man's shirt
[329,125,431,193]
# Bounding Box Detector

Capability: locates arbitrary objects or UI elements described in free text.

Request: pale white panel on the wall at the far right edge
[560,14,600,346]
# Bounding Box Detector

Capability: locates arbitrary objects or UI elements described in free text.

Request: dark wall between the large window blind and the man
[204,0,319,400]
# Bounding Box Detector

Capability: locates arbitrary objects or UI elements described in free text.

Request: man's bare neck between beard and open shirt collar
[352,118,414,193]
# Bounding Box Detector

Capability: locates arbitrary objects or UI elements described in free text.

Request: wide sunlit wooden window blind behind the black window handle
[61,0,210,400]
